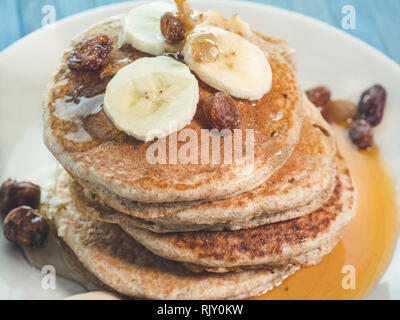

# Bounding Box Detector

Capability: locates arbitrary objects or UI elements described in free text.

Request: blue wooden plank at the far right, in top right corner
[365,0,400,63]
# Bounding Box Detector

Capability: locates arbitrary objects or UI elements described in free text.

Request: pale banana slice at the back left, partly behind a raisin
[118,2,178,56]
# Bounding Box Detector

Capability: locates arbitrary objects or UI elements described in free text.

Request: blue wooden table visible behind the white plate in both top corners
[0,0,400,63]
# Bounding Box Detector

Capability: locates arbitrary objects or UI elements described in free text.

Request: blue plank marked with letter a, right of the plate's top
[327,0,388,54]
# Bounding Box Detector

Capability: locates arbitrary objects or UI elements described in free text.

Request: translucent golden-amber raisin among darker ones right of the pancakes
[322,100,357,123]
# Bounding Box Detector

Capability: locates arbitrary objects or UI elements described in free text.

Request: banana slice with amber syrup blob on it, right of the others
[183,23,272,100]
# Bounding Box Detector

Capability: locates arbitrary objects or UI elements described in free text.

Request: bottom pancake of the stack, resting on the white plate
[48,174,298,300]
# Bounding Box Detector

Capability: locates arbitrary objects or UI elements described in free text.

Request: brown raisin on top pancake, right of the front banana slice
[202,92,242,131]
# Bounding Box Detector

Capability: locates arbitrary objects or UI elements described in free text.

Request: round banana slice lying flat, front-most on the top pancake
[104,56,199,141]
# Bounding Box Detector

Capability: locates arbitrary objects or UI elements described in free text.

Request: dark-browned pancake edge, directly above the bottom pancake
[121,156,356,272]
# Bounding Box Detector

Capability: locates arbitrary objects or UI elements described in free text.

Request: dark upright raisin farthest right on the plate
[357,85,386,127]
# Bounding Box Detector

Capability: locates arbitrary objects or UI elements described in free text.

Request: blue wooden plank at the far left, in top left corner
[0,0,22,50]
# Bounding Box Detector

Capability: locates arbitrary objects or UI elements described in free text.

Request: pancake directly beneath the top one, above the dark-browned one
[72,99,336,232]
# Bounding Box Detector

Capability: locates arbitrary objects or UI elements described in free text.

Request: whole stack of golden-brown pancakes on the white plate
[44,17,356,299]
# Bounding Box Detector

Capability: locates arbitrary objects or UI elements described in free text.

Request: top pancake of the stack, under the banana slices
[44,17,303,202]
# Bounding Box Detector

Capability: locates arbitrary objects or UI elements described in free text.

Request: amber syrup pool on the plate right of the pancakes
[255,126,399,300]
